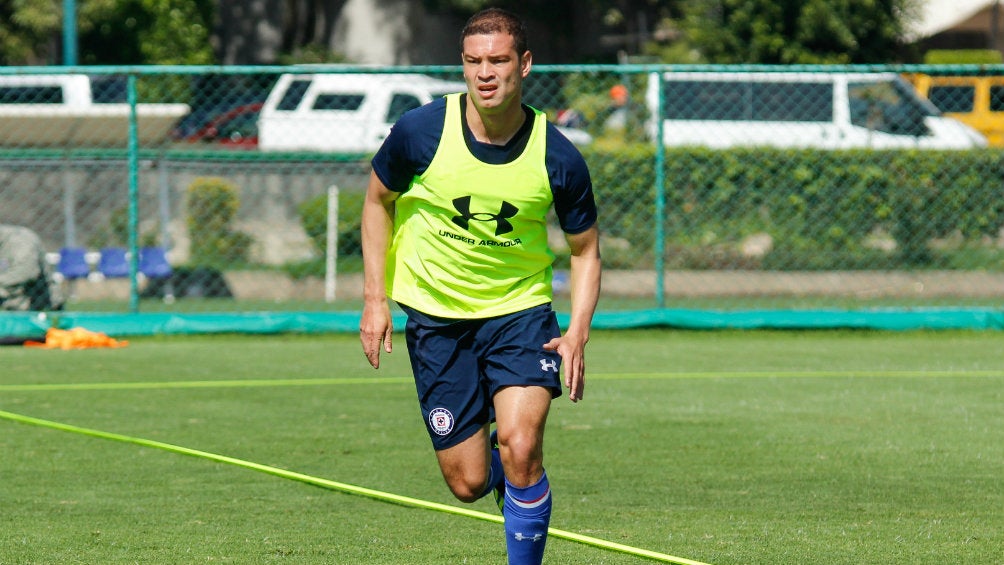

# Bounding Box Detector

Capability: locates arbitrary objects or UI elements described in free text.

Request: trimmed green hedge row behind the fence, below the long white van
[585,146,1004,269]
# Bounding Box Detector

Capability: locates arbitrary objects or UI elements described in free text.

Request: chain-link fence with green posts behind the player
[0,66,1004,321]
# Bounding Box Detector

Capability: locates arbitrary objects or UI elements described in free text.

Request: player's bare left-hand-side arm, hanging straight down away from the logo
[359,173,399,368]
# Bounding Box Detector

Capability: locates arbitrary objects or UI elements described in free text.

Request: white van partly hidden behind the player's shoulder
[258,73,592,153]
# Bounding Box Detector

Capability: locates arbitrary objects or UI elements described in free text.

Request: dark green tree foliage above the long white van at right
[681,0,919,64]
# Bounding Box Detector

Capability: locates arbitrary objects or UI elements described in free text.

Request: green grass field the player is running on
[0,330,1004,565]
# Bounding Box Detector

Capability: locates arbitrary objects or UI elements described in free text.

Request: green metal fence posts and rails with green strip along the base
[0,64,1004,334]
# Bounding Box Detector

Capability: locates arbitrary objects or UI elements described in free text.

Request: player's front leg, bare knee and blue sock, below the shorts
[494,386,551,565]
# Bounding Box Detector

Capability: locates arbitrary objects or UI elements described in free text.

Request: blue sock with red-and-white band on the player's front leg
[503,473,551,565]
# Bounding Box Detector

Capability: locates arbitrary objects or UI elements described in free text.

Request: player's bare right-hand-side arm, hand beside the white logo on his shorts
[544,225,601,402]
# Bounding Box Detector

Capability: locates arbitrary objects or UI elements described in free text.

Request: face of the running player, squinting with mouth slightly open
[462,33,530,113]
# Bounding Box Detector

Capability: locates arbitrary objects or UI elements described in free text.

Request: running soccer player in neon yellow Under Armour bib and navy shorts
[360,8,600,565]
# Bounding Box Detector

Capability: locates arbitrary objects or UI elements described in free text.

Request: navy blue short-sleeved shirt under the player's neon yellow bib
[371,94,596,234]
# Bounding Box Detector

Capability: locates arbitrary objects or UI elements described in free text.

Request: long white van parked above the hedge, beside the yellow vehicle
[646,72,987,150]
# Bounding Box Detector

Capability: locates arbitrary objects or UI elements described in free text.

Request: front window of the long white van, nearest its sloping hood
[847,81,936,136]
